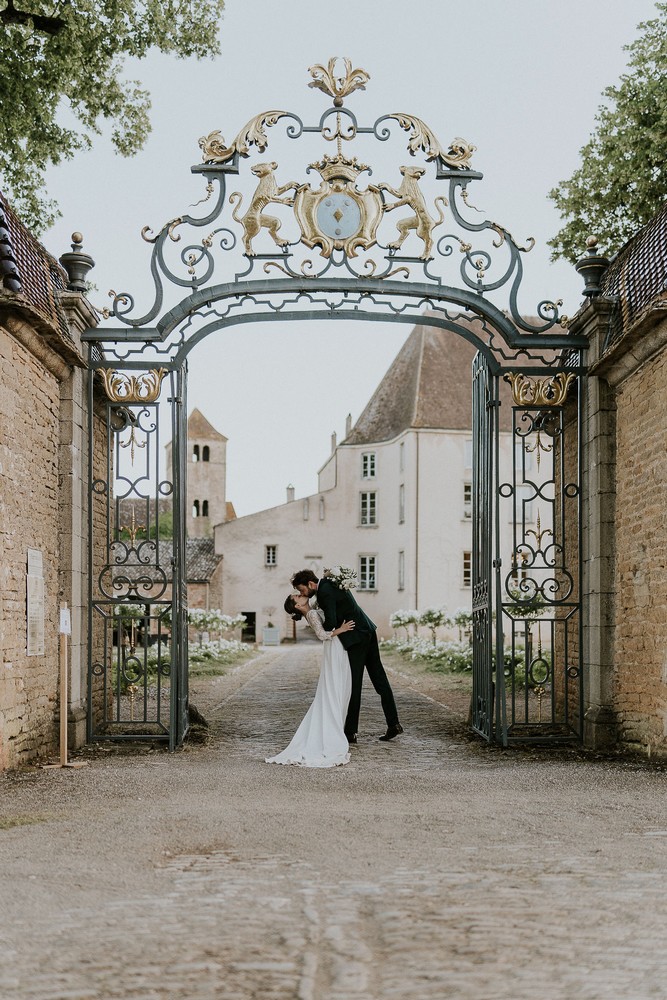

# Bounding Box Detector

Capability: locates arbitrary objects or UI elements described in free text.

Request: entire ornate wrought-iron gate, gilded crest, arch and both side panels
[82,52,586,748]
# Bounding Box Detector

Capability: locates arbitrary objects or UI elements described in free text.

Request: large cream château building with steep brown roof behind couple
[215,325,535,637]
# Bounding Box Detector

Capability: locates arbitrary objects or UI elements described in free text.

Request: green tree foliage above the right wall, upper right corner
[549,3,667,263]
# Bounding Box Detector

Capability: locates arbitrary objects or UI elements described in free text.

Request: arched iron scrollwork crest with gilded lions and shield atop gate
[92,59,576,352]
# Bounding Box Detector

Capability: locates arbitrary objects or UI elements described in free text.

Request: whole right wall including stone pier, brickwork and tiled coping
[570,248,667,755]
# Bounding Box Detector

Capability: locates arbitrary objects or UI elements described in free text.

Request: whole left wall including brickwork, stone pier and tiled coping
[0,205,97,770]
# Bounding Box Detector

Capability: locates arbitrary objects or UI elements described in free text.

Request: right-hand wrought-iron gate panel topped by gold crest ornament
[504,368,583,741]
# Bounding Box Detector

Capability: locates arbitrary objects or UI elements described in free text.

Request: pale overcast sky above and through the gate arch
[44,0,655,514]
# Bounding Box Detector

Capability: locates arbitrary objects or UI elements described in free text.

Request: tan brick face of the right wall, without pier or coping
[614,352,667,752]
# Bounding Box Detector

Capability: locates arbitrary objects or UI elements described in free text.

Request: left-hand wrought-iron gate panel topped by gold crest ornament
[88,364,188,749]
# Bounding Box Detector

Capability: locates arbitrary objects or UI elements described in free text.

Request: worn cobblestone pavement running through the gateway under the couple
[0,644,667,1000]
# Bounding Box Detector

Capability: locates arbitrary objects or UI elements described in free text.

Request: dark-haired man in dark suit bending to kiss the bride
[292,569,403,743]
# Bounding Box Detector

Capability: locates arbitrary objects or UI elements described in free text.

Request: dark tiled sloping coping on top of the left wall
[0,193,72,343]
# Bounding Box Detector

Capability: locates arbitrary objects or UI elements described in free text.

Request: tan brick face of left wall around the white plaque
[0,328,60,770]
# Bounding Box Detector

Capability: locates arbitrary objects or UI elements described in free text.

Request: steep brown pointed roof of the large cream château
[343,323,510,444]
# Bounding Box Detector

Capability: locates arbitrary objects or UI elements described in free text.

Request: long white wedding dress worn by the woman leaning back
[265,608,352,767]
